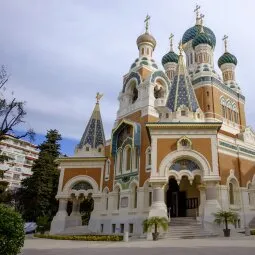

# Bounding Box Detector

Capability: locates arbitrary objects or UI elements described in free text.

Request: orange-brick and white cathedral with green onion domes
[50,7,255,236]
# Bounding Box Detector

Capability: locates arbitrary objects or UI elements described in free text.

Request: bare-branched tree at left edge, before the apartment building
[0,66,34,202]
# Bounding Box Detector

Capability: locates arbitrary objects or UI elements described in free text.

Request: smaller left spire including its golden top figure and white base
[77,93,105,155]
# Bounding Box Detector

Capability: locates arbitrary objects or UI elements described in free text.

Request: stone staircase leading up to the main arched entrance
[162,217,218,239]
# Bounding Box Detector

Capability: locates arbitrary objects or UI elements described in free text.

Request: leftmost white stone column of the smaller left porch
[50,198,68,234]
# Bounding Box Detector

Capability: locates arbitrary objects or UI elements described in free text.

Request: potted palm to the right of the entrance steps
[213,210,238,237]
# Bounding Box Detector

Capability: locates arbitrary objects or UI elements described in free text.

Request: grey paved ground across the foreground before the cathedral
[21,237,255,255]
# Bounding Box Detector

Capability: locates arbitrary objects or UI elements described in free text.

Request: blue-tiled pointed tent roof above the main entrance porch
[166,49,199,112]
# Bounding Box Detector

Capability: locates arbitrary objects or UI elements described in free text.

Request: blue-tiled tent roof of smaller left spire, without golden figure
[78,102,105,149]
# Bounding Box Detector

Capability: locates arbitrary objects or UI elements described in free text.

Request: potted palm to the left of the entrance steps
[143,217,168,241]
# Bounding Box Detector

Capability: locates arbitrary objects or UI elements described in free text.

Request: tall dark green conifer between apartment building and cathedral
[18,130,61,221]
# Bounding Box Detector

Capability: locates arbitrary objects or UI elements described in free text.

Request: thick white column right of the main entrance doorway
[204,181,221,222]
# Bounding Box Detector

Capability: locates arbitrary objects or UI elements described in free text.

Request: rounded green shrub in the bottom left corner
[0,204,25,255]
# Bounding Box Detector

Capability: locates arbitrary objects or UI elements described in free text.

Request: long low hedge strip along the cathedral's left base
[34,234,123,241]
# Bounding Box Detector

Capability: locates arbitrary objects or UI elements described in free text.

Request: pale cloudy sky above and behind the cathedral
[0,0,255,155]
